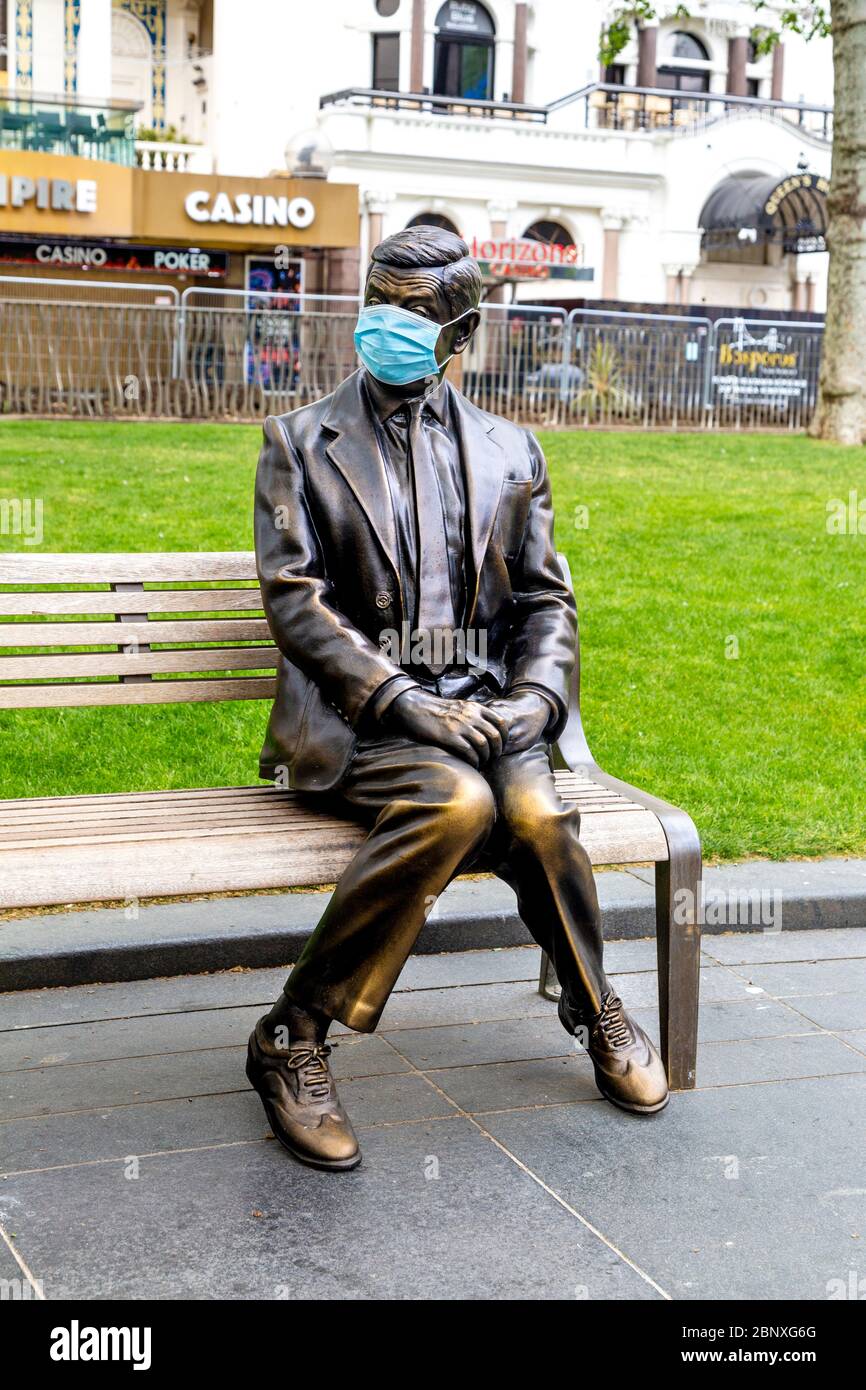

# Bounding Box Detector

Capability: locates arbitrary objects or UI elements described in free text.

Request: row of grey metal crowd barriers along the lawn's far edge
[0,277,823,430]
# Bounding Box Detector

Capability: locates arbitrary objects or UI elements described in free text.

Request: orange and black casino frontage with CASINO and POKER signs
[0,150,359,296]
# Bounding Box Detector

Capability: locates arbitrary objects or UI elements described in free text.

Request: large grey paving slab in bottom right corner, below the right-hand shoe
[482,1074,866,1301]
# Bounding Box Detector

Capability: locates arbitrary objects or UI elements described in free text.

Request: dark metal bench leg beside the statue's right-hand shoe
[656,835,701,1091]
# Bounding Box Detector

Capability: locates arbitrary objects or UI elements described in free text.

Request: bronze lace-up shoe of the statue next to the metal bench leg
[559,990,670,1115]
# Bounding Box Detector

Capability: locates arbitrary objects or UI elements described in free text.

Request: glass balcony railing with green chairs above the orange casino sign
[0,92,138,164]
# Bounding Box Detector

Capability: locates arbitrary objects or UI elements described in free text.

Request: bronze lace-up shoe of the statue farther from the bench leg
[246,1030,361,1170]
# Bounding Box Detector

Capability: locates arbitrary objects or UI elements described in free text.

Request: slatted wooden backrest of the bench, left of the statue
[0,550,277,709]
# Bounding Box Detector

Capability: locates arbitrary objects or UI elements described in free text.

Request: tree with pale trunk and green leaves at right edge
[599,0,866,445]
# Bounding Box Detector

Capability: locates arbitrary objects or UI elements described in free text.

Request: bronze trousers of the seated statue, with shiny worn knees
[285,738,607,1033]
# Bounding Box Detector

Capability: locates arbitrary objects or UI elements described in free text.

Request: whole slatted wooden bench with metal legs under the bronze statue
[0,552,701,1090]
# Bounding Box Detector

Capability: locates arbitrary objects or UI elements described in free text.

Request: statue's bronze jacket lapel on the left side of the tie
[322,371,400,580]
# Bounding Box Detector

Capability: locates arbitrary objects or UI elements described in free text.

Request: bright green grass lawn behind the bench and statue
[0,421,866,859]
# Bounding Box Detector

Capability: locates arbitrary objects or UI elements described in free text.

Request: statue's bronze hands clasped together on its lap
[386,685,550,767]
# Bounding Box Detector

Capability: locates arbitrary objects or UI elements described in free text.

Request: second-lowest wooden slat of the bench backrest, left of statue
[0,644,277,681]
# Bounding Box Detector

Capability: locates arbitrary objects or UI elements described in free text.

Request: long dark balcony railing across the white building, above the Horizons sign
[318,82,833,142]
